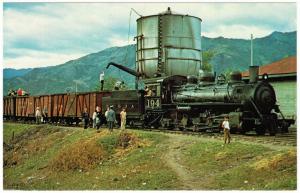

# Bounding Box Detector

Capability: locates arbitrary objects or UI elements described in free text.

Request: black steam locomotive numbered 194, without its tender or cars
[108,63,294,135]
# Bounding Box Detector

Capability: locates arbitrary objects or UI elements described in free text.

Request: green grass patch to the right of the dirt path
[182,141,297,190]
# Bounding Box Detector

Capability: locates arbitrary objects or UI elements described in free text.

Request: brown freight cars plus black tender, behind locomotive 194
[3,90,144,126]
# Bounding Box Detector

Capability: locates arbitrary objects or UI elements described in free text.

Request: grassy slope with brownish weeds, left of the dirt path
[4,123,178,190]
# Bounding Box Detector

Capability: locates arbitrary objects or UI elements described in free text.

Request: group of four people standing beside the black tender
[82,105,126,132]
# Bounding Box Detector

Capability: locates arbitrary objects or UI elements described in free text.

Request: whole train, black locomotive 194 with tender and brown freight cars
[3,71,294,135]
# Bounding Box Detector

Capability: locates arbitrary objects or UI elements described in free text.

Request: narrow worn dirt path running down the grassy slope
[163,135,201,190]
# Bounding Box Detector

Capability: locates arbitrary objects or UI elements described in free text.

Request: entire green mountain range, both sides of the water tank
[3,32,296,95]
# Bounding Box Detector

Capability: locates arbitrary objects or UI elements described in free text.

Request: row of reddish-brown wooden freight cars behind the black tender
[3,92,111,124]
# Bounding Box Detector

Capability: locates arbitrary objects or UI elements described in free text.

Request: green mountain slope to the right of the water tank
[202,32,297,73]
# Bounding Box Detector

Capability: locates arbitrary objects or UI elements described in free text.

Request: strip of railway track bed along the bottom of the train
[5,121,297,146]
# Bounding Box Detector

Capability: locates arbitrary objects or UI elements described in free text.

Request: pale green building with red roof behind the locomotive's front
[242,56,297,117]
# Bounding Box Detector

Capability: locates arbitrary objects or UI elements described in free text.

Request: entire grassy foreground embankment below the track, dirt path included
[4,123,296,190]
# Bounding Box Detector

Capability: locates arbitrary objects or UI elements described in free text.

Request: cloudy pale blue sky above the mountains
[3,2,297,69]
